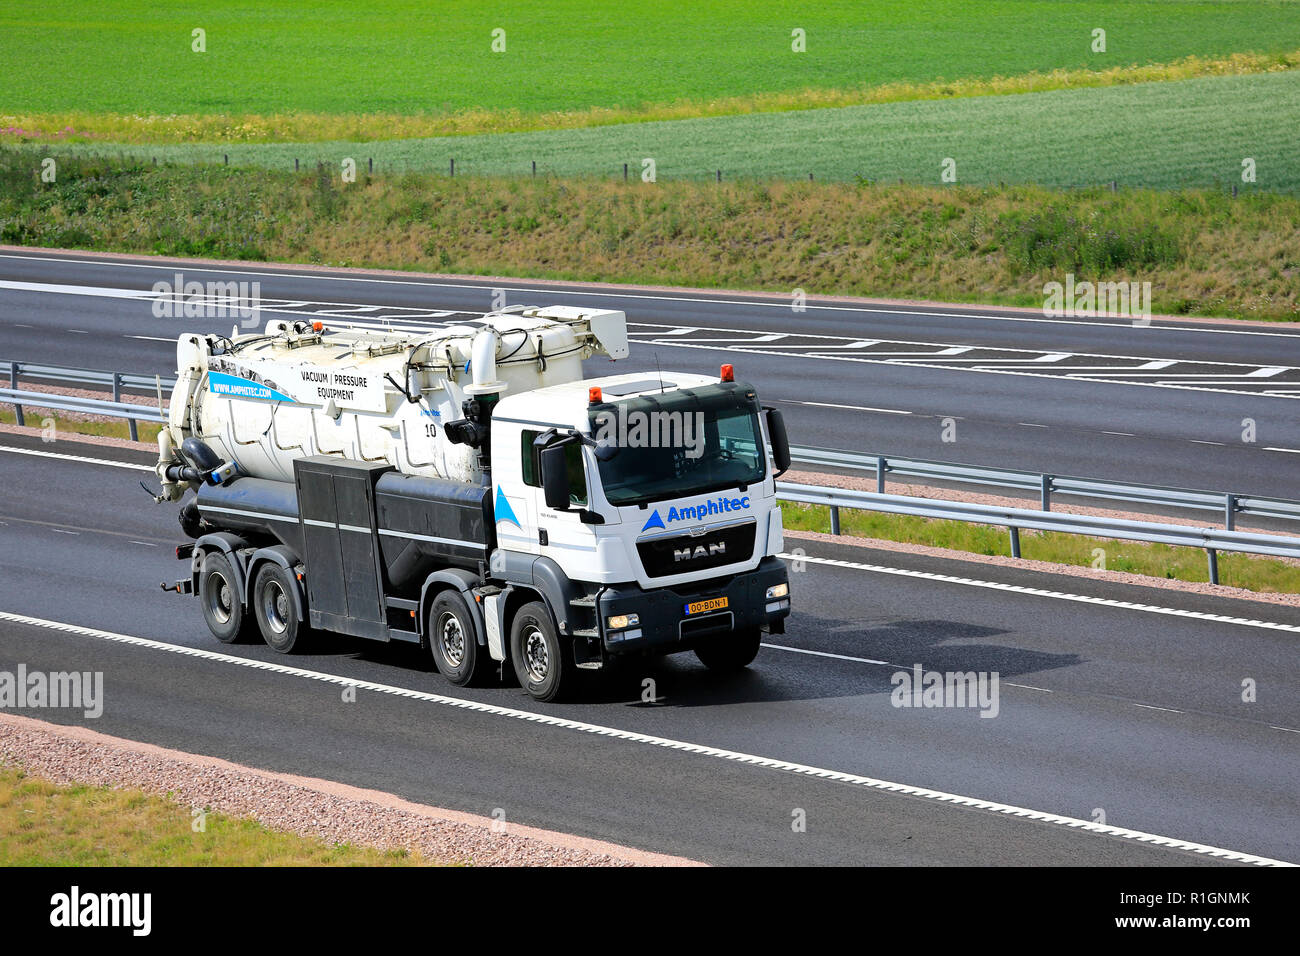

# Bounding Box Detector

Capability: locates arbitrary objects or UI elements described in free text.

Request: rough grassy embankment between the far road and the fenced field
[0,150,1300,319]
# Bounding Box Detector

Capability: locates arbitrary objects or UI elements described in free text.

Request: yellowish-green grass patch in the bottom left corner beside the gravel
[0,766,428,866]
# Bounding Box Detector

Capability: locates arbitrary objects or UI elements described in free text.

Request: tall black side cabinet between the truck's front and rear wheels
[294,455,391,640]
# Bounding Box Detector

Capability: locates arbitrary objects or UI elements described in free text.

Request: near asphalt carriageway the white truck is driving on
[0,436,1300,862]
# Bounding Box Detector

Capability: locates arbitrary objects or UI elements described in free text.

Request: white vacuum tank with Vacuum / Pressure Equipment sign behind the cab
[159,306,628,499]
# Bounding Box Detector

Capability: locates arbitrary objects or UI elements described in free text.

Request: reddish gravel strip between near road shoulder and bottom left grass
[0,713,699,866]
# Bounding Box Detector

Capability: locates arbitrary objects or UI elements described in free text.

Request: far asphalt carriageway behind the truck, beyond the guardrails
[0,251,1300,497]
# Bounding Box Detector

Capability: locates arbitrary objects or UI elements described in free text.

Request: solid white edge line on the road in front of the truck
[0,611,1295,866]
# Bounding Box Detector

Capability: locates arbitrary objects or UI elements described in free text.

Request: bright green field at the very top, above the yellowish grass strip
[0,0,1300,130]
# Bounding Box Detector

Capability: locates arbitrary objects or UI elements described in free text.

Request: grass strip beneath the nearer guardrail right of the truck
[781,502,1300,594]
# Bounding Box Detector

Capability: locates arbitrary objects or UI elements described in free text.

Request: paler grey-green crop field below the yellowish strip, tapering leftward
[30,70,1300,193]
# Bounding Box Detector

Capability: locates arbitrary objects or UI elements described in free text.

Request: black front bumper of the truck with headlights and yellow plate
[597,557,790,654]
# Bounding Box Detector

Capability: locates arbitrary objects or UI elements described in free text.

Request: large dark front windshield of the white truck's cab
[590,382,766,505]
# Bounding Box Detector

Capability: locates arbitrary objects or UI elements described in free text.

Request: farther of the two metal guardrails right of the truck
[790,447,1300,531]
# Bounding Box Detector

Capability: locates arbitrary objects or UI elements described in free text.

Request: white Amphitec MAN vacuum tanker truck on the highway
[147,307,790,701]
